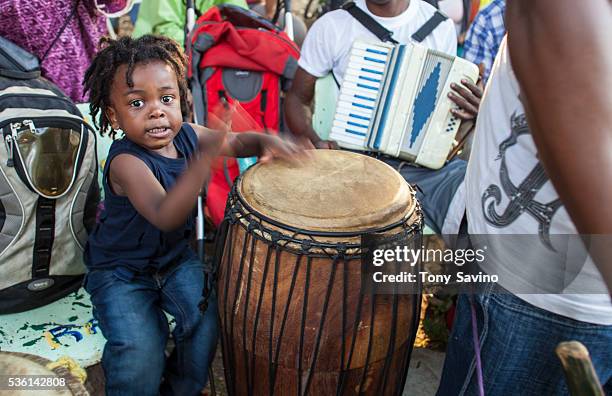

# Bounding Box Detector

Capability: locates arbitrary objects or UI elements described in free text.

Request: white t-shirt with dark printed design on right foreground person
[465,38,612,325]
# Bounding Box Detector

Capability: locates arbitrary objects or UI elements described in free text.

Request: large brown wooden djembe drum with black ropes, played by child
[217,150,422,395]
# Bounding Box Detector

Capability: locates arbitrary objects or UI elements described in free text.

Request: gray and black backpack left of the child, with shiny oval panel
[0,37,100,314]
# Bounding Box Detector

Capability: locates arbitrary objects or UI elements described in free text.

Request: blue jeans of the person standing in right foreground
[437,290,612,396]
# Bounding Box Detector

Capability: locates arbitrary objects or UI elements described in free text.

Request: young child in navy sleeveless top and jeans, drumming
[84,36,297,396]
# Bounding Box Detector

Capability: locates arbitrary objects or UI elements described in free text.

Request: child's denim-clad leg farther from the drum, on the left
[85,270,168,396]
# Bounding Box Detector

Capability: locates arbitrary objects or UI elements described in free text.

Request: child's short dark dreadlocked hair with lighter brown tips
[83,35,189,139]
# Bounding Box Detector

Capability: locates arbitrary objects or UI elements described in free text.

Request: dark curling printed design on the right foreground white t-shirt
[482,112,562,251]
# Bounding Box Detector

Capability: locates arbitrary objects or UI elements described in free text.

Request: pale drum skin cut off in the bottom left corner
[0,352,89,396]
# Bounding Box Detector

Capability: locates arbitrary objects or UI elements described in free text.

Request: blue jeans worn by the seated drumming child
[85,260,218,396]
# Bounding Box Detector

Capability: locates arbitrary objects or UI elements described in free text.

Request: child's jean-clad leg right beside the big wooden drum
[157,260,218,395]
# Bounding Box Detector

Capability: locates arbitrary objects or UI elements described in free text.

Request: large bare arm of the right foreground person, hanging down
[506,0,612,290]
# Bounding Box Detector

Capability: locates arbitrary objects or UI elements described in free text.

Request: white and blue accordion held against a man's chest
[330,41,478,169]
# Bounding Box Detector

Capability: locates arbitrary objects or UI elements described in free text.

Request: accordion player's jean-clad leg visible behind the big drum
[384,158,467,234]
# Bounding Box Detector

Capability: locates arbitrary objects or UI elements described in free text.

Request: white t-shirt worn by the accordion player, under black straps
[298,0,457,84]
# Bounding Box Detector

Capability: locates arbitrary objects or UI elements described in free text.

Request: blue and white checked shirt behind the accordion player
[463,0,506,83]
